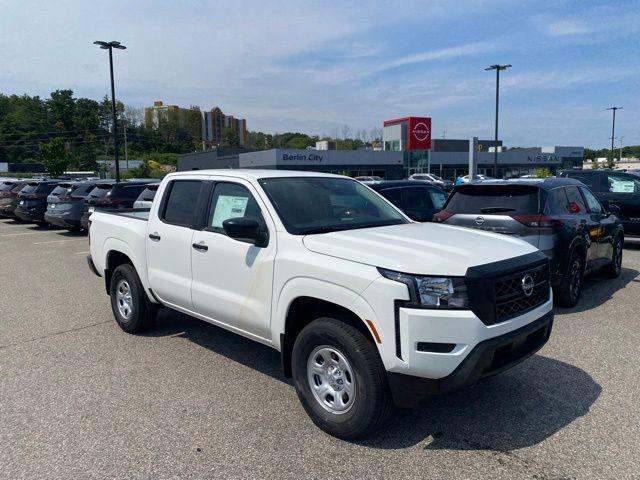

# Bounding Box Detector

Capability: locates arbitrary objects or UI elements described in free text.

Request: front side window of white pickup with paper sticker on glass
[207,183,265,233]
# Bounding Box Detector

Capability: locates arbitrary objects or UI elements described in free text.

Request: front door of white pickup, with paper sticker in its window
[191,177,276,339]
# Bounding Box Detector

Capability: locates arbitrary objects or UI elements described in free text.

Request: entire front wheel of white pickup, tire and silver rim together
[292,318,393,439]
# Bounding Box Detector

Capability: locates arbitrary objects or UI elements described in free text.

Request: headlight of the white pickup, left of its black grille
[378,268,469,308]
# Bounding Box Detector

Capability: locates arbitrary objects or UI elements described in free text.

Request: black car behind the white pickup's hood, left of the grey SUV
[366,180,447,222]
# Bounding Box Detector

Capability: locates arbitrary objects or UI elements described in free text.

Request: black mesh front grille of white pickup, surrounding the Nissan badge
[493,265,549,322]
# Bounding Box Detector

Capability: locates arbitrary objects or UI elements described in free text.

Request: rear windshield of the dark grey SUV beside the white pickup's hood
[445,185,541,215]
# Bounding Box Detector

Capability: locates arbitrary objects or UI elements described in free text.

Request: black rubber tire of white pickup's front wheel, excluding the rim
[292,317,393,440]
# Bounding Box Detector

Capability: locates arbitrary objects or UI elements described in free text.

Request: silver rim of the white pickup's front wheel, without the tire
[307,345,356,415]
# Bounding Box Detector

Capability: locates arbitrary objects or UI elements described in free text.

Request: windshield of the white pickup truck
[259,177,408,235]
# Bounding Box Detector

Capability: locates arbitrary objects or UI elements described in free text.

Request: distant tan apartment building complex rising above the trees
[144,101,247,147]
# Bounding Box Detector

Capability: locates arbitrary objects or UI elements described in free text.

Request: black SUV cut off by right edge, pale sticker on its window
[560,170,640,236]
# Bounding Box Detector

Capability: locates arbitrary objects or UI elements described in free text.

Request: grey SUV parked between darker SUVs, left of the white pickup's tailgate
[44,181,96,230]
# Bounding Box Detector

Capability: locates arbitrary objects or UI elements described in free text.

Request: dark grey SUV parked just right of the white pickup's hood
[434,178,624,307]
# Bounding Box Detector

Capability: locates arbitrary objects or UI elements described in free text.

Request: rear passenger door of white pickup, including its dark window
[147,176,205,310]
